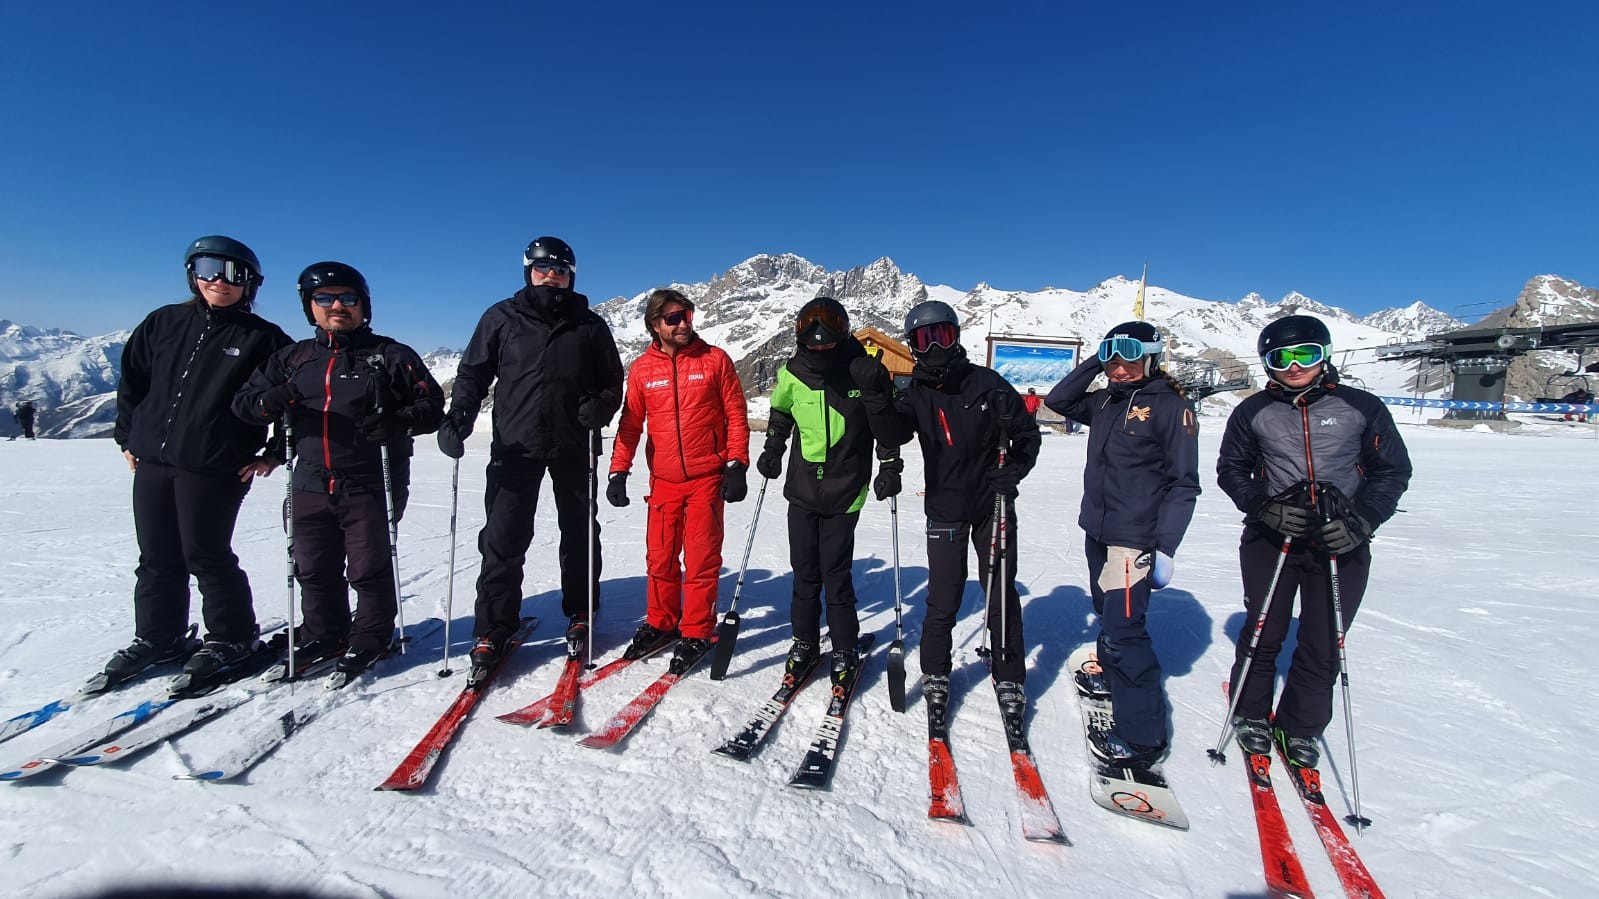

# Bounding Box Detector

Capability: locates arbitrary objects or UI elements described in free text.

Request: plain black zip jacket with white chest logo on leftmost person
[112,301,293,473]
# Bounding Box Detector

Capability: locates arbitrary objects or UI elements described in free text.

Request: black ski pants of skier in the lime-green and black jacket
[788,502,860,651]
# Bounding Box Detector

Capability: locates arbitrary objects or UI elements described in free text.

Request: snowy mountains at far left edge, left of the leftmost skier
[0,318,128,437]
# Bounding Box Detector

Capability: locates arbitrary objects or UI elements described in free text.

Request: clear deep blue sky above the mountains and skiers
[0,2,1599,350]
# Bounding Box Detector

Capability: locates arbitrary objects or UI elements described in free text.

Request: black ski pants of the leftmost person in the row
[133,462,256,643]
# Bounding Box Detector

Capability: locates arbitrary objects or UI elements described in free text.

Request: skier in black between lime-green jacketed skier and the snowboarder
[851,301,1041,720]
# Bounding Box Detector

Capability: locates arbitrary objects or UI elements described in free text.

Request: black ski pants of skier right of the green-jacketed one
[921,499,1027,683]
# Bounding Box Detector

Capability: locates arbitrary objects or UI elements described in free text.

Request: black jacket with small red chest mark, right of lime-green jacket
[892,360,1043,523]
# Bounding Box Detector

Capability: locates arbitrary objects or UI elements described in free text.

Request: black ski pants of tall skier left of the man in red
[472,454,601,638]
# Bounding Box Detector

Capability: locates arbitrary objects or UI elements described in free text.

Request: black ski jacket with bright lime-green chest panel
[764,338,903,515]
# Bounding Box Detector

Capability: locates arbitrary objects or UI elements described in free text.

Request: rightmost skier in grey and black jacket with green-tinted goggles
[1215,315,1410,768]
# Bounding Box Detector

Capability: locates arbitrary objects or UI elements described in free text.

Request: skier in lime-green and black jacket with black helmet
[755,296,900,683]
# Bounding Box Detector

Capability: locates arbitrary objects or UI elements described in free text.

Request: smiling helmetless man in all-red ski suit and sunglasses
[604,288,750,657]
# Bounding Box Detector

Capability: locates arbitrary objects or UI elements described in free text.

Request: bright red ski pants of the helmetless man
[644,475,723,640]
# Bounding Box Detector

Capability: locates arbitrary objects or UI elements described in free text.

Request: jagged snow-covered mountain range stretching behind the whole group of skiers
[0,262,1599,437]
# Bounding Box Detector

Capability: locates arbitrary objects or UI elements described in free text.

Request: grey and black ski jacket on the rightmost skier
[1215,365,1410,531]
